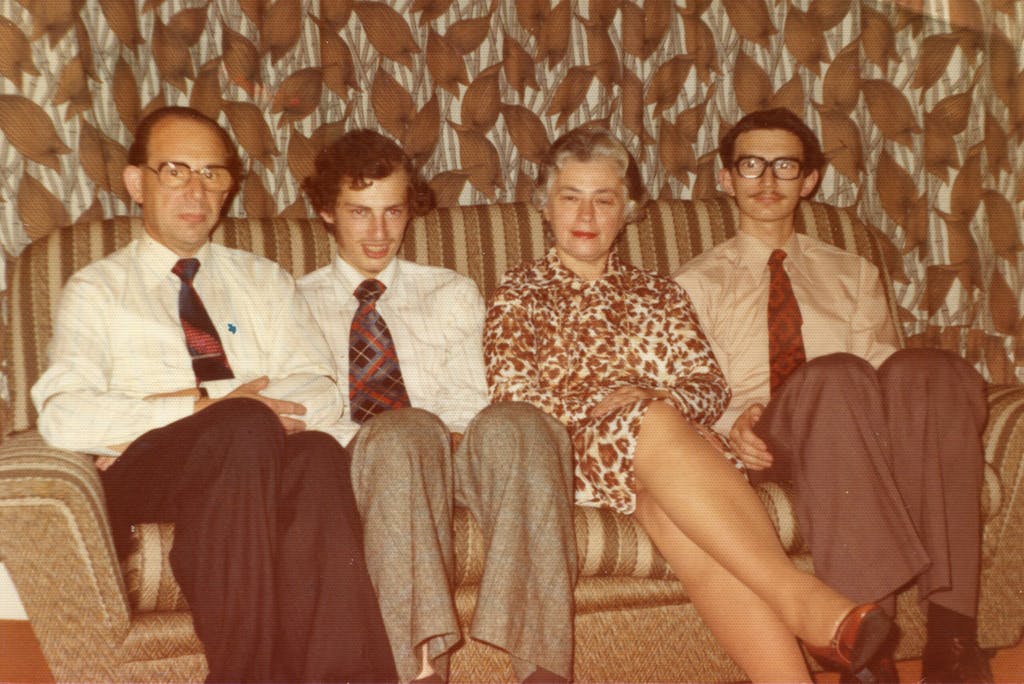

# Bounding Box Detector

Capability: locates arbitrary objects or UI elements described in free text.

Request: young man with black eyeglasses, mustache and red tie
[676,110,992,682]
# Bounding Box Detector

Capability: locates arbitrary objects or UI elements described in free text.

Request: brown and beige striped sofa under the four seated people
[0,198,1024,682]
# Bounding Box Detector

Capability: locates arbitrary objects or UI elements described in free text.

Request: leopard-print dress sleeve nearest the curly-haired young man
[483,284,592,423]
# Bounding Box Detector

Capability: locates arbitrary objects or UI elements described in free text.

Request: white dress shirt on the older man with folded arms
[32,236,344,455]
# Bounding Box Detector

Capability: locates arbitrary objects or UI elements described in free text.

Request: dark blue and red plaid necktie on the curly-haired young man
[348,280,411,423]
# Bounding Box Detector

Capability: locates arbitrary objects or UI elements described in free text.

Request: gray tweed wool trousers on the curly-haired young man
[349,402,577,682]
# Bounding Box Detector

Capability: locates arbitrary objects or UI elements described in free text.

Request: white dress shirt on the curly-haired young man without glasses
[299,257,487,444]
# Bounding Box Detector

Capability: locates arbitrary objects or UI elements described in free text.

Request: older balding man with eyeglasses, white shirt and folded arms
[33,108,397,682]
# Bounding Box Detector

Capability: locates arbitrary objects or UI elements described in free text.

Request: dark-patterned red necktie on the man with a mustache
[768,250,807,394]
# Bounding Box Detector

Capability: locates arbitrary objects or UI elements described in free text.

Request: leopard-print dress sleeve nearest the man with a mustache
[666,284,732,425]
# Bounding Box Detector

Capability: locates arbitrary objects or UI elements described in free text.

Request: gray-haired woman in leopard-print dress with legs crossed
[484,128,890,682]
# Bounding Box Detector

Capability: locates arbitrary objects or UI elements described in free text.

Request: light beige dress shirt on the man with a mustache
[674,232,898,434]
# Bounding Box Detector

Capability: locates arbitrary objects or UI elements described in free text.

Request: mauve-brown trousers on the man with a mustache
[750,349,987,615]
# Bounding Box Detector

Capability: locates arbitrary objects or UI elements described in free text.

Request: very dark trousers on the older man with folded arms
[102,399,396,682]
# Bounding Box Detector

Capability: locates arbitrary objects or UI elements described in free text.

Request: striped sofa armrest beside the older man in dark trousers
[0,430,130,681]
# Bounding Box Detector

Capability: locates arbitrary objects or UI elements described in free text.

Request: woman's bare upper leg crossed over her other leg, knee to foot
[634,401,854,659]
